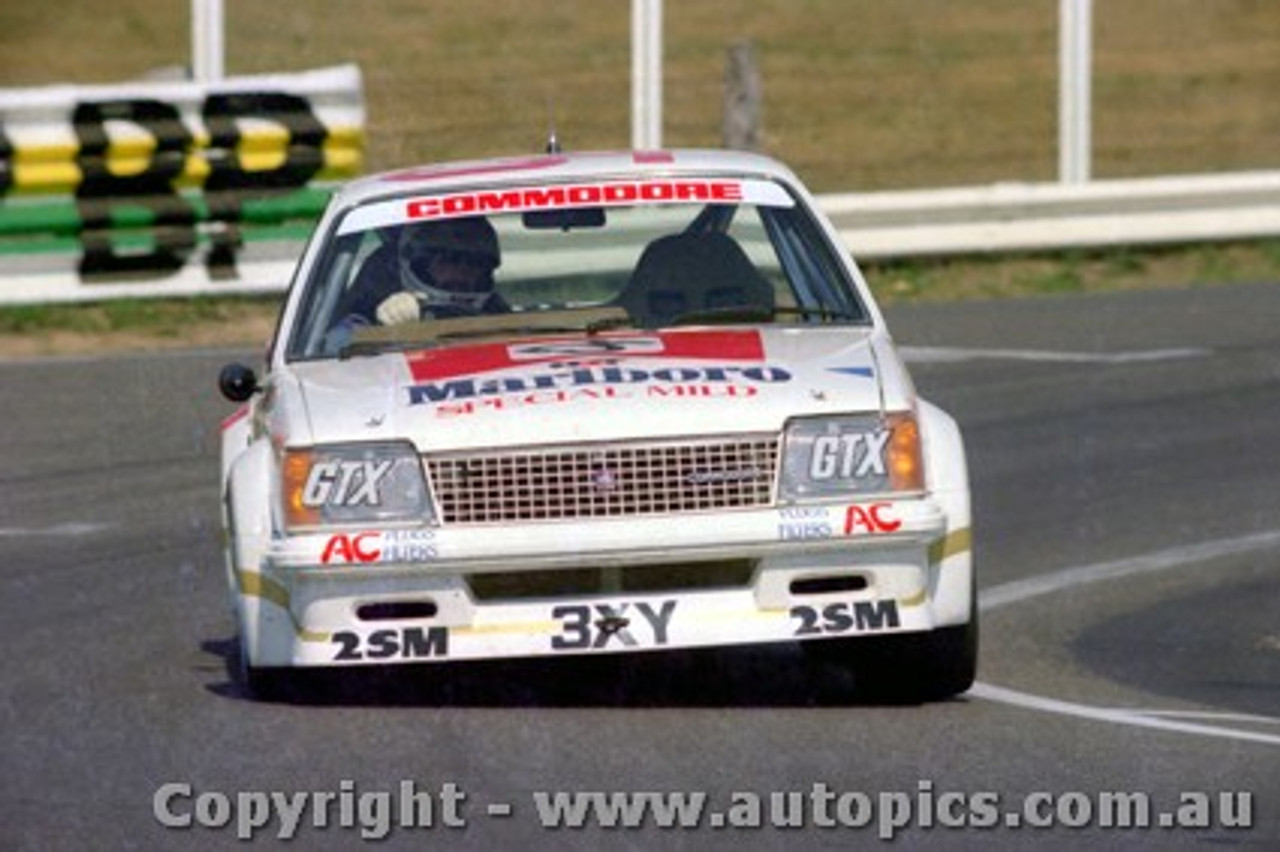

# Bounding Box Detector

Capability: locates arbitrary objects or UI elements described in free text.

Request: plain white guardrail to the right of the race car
[818,171,1280,260]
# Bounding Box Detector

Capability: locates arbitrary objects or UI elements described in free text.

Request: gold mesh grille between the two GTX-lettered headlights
[426,435,780,523]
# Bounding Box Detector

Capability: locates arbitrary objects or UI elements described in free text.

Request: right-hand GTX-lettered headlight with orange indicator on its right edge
[781,412,924,500]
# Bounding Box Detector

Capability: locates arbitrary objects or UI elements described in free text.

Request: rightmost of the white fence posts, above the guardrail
[1057,0,1093,183]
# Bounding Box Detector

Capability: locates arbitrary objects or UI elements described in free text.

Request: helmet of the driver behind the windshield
[397,216,502,311]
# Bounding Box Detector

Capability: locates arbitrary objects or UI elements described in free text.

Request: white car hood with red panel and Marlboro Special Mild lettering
[292,326,914,452]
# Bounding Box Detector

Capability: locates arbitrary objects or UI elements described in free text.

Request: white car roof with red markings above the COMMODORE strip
[337,150,796,206]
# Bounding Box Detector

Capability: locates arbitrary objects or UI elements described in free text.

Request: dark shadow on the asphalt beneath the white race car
[202,637,964,707]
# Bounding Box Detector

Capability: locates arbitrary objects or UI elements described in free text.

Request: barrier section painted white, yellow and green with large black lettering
[0,65,365,304]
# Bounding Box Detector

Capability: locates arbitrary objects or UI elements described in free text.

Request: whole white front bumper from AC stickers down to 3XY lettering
[237,499,972,667]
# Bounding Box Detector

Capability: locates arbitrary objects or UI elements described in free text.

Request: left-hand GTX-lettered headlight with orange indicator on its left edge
[283,443,431,530]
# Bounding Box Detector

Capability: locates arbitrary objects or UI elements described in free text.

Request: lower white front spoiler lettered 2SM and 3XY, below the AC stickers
[238,518,973,667]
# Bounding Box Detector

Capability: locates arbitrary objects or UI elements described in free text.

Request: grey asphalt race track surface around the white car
[0,285,1280,852]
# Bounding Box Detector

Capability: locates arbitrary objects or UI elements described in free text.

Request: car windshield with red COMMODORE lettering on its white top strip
[288,172,869,359]
